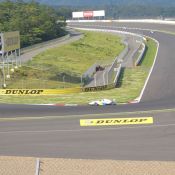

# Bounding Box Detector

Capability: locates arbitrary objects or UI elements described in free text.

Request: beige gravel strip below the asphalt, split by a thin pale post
[0,157,175,175]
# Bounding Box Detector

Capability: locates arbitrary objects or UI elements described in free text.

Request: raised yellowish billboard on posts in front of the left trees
[1,31,20,52]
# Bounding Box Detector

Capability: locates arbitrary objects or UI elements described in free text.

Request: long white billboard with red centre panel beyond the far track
[72,10,105,19]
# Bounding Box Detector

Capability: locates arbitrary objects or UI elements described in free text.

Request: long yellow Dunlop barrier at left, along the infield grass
[0,87,82,96]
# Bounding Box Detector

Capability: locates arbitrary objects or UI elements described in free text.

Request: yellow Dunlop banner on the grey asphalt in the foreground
[80,117,153,126]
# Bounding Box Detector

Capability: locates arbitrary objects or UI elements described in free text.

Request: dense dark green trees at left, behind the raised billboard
[0,0,65,47]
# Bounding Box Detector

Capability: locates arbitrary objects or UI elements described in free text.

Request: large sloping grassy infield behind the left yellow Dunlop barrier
[8,31,125,89]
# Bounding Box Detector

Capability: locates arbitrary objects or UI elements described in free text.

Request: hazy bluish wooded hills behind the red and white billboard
[30,0,175,19]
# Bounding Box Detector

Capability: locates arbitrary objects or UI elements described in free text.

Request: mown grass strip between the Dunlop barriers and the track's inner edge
[0,39,157,104]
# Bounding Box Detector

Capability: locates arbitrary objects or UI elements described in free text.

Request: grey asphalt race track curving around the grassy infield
[0,23,175,161]
